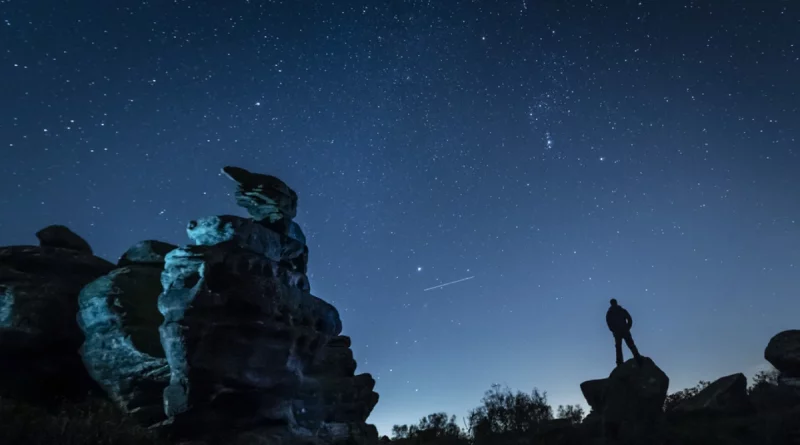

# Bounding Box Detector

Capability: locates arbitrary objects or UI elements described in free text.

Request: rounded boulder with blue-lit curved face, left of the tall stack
[78,264,170,425]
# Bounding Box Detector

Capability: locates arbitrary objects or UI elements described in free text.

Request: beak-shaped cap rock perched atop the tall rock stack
[222,167,297,222]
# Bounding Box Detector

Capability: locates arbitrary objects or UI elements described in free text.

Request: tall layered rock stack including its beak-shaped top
[158,167,377,443]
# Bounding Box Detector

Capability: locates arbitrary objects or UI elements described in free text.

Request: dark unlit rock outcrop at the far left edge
[0,226,114,401]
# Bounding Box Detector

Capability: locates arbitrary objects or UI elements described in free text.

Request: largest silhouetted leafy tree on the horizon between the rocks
[468,385,553,439]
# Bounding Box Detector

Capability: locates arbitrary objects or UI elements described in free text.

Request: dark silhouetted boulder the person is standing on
[581,357,669,443]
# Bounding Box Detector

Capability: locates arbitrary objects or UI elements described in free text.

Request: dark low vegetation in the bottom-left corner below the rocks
[0,398,164,445]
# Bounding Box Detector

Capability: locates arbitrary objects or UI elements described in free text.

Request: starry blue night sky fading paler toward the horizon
[0,0,800,433]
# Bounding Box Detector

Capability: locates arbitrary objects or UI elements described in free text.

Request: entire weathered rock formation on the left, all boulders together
[0,167,378,445]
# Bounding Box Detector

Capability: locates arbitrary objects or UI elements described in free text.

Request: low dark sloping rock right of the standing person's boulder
[673,373,752,415]
